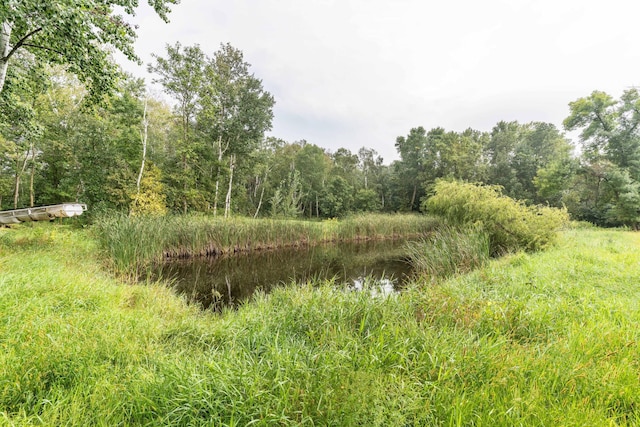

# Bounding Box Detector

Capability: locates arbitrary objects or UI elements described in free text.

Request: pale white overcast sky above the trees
[116,0,640,164]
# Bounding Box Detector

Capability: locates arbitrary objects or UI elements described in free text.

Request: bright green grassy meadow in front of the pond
[0,224,640,426]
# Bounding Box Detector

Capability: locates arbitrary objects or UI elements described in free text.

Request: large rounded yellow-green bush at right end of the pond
[422,181,569,255]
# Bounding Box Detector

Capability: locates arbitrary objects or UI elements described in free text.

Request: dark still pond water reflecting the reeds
[156,240,412,309]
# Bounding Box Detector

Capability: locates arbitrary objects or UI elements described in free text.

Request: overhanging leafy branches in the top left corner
[0,0,179,101]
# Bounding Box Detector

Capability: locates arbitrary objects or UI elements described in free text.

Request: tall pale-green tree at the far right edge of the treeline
[564,88,640,228]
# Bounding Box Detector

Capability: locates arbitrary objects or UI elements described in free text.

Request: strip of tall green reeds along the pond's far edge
[95,214,439,275]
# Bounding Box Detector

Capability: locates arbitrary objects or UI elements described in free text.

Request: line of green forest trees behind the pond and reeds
[0,44,640,228]
